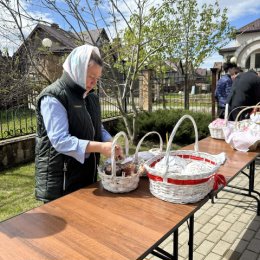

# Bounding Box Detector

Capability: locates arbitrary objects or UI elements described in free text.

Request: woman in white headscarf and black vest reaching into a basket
[35,45,122,202]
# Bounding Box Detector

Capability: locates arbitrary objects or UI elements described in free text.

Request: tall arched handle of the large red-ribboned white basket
[163,115,199,177]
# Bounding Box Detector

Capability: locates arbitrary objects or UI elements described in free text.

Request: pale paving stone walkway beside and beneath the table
[146,160,260,260]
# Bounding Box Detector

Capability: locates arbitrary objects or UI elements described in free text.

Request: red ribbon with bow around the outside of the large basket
[147,172,226,190]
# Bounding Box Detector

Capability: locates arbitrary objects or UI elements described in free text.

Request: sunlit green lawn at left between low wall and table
[0,163,42,221]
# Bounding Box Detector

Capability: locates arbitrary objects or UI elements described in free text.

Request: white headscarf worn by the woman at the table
[63,44,100,89]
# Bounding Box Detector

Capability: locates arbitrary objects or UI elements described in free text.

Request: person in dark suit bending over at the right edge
[227,70,260,121]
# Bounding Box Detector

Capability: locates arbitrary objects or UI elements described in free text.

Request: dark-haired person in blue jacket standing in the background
[215,62,237,118]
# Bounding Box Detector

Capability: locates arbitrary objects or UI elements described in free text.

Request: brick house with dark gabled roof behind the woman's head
[14,23,109,82]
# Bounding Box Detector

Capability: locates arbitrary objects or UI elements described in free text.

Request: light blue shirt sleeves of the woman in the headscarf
[41,96,112,163]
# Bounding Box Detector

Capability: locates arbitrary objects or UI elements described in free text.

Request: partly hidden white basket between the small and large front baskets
[134,131,163,177]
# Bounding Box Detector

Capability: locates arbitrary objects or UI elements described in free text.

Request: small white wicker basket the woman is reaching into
[98,131,139,193]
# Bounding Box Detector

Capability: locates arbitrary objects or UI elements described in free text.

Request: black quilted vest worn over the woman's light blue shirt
[35,72,101,201]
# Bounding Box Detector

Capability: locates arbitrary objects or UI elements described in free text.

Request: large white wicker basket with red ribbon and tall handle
[144,115,225,204]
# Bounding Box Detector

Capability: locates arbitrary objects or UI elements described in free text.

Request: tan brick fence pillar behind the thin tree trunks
[139,69,152,112]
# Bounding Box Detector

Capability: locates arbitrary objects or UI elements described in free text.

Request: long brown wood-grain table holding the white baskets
[0,138,257,260]
